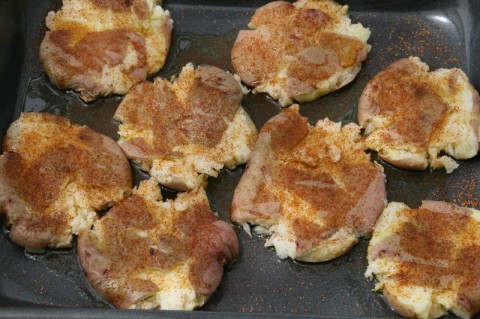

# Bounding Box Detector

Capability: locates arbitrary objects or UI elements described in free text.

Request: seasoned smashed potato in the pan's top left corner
[40,0,172,102]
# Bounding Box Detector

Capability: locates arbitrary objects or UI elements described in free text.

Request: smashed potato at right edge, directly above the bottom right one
[358,57,480,173]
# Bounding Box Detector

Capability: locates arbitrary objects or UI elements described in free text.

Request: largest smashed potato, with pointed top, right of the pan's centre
[231,105,386,262]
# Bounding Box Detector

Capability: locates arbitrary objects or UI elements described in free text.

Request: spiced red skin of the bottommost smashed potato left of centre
[77,188,239,308]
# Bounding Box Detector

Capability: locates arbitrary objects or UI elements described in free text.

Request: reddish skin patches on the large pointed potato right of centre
[231,109,386,260]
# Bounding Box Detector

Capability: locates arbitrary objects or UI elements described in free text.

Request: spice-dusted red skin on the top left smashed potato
[40,30,148,102]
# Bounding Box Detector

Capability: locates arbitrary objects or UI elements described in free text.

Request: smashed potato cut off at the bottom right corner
[365,201,480,319]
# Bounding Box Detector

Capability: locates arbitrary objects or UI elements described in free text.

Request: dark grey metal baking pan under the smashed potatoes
[0,0,480,318]
